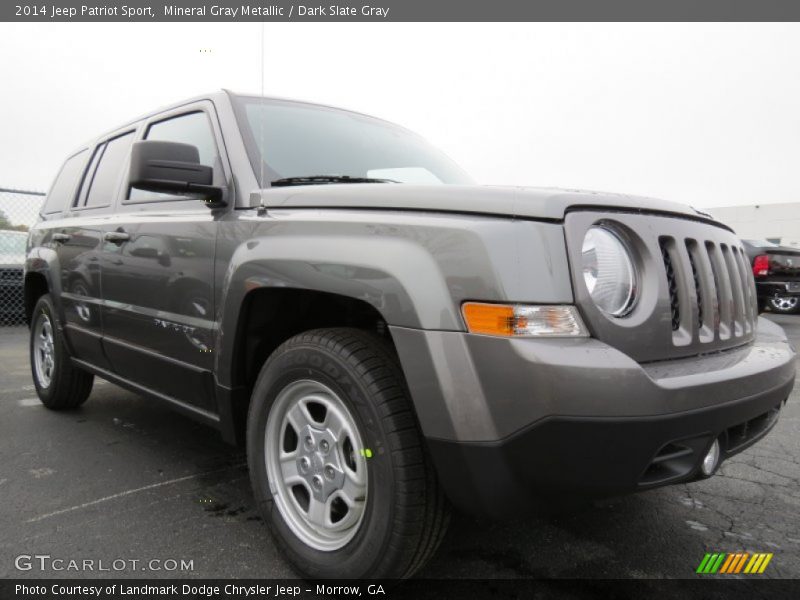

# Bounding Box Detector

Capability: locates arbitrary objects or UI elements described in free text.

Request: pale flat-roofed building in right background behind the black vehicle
[704,202,800,248]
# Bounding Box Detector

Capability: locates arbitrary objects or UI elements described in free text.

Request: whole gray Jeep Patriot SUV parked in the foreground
[24,92,795,578]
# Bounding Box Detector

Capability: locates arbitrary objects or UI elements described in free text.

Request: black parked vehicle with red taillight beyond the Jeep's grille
[742,240,800,314]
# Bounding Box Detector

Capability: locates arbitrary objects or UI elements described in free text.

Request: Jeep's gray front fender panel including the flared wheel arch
[215,211,572,385]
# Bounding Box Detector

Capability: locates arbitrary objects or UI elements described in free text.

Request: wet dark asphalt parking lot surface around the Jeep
[0,316,800,578]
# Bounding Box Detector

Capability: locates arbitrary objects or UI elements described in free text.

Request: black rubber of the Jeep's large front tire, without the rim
[247,328,450,579]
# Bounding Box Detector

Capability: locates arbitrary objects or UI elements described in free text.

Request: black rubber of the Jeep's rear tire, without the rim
[29,294,94,410]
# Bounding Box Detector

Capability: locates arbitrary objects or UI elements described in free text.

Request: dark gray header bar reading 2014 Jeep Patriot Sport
[0,0,800,22]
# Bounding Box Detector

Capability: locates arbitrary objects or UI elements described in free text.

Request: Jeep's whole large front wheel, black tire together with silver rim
[247,329,449,579]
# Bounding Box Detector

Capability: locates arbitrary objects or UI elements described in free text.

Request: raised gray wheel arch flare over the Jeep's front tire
[217,236,463,381]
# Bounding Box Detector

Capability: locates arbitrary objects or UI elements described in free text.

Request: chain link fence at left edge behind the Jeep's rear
[0,187,45,325]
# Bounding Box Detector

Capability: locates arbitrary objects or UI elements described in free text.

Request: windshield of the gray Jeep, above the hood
[233,96,472,187]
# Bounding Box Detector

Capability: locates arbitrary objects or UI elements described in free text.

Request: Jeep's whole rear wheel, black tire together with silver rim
[30,294,94,410]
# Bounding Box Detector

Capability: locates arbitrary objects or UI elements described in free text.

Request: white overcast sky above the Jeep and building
[0,23,800,206]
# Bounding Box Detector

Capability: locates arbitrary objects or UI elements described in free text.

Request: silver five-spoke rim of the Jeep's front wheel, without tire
[264,380,367,552]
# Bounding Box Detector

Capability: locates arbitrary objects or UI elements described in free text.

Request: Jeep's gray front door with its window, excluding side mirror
[103,101,229,412]
